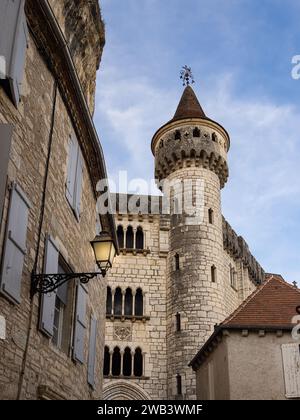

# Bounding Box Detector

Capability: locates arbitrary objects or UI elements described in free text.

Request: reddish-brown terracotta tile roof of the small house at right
[221,274,300,327]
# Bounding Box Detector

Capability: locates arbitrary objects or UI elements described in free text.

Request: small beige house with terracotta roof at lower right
[191,274,300,400]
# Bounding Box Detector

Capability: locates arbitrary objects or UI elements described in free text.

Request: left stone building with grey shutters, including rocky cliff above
[0,0,116,399]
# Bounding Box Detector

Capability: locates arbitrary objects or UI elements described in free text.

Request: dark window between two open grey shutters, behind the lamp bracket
[52,256,73,354]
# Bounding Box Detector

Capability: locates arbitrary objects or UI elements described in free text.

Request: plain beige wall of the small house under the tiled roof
[196,330,295,400]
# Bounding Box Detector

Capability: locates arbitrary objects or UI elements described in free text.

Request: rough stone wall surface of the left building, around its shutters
[0,16,106,399]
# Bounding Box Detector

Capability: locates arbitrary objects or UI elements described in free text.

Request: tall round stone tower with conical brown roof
[152,86,230,399]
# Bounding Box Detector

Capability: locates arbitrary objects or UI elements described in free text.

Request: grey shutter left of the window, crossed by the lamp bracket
[40,236,59,337]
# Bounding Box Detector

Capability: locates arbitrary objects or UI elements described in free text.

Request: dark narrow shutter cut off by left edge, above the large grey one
[0,124,13,220]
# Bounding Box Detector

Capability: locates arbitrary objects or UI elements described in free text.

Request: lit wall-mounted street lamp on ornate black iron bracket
[31,231,116,297]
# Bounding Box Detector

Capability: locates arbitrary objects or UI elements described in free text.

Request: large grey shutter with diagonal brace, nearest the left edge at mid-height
[0,183,30,303]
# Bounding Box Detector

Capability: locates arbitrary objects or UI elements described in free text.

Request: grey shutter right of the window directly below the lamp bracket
[73,284,87,363]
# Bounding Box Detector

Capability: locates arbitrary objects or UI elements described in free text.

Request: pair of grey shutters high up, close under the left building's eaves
[66,134,83,221]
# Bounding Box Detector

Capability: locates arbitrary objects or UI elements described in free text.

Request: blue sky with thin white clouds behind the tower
[94,0,300,285]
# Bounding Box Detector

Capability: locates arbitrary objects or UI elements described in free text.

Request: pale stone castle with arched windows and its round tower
[104,86,264,399]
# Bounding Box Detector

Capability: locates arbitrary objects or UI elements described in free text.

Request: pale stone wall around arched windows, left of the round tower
[104,216,167,399]
